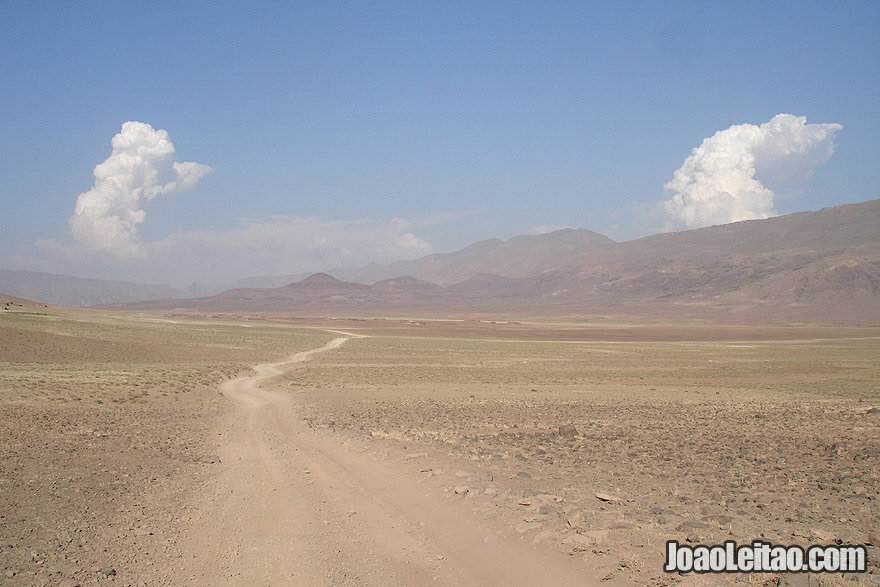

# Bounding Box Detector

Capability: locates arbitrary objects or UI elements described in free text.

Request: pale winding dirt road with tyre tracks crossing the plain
[172,331,596,585]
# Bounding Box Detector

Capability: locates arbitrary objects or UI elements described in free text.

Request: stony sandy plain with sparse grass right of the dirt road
[289,328,880,584]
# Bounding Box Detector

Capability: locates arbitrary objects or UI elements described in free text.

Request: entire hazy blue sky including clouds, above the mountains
[0,1,880,285]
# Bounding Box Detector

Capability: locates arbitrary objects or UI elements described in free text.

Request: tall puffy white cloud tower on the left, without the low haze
[69,121,212,257]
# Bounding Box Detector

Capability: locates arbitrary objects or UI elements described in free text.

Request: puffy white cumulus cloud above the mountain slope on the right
[663,114,843,228]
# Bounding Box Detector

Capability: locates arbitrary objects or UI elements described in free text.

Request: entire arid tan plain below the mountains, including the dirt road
[0,306,880,585]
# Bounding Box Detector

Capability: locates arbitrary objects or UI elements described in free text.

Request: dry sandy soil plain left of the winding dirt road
[0,311,329,585]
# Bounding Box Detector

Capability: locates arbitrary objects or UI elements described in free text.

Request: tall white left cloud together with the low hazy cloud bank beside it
[32,122,438,284]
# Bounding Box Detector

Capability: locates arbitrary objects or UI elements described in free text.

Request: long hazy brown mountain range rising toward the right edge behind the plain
[98,200,880,323]
